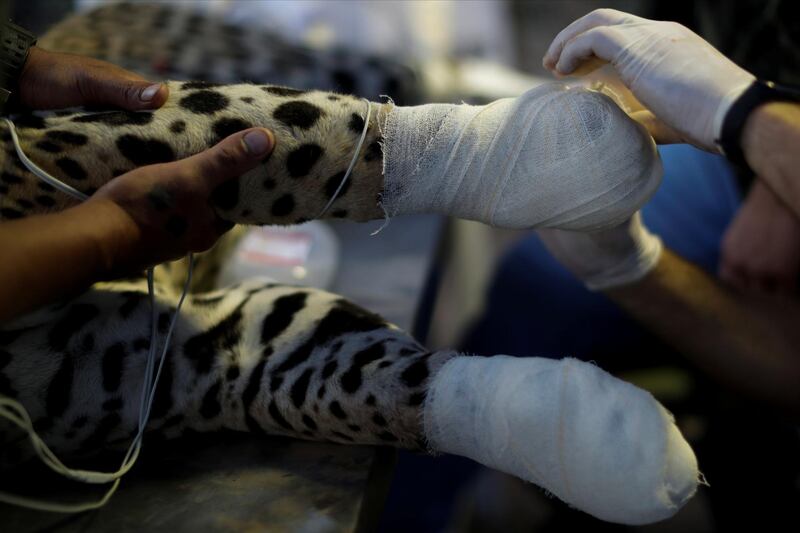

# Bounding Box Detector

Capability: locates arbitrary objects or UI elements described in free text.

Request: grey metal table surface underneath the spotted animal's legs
[0,215,443,533]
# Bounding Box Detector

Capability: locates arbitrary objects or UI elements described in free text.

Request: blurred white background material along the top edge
[77,0,513,64]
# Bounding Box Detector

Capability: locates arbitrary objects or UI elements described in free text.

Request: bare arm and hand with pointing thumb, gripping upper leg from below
[0,128,274,321]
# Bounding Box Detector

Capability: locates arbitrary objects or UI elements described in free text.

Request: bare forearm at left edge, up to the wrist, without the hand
[0,201,136,321]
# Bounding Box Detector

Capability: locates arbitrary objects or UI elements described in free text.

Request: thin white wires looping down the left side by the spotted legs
[0,118,194,513]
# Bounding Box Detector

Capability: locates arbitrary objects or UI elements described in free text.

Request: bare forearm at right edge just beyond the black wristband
[741,102,800,215]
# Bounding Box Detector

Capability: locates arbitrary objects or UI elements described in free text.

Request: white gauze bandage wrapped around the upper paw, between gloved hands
[383,83,662,230]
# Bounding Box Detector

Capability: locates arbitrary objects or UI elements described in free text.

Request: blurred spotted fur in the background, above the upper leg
[39,3,422,105]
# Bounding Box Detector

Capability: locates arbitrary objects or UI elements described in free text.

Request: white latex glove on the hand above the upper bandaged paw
[543,9,755,151]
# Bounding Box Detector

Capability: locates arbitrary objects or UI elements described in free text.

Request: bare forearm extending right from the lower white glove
[607,251,800,418]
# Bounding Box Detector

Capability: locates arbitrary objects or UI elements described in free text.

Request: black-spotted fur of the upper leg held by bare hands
[0,82,386,224]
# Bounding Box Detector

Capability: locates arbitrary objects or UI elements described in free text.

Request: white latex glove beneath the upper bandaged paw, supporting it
[538,213,663,291]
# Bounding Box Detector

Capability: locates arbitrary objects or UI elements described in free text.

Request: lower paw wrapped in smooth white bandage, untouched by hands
[424,355,699,525]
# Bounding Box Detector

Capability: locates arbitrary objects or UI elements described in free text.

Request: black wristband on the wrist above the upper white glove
[717,80,800,168]
